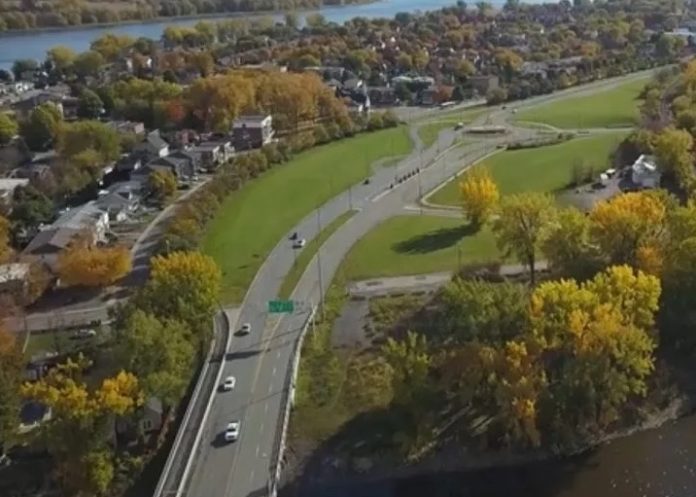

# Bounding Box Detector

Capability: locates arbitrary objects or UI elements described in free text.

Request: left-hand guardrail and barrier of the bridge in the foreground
[153,312,232,497]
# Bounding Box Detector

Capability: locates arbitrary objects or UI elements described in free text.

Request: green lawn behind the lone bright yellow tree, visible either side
[428,133,625,205]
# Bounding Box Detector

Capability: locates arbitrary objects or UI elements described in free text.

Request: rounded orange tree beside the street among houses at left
[57,240,131,287]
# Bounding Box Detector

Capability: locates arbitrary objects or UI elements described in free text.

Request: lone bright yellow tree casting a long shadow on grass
[459,166,500,229]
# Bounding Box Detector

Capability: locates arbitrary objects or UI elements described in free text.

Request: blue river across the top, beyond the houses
[0,0,524,69]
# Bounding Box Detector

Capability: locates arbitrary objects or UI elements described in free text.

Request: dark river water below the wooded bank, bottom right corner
[294,415,696,497]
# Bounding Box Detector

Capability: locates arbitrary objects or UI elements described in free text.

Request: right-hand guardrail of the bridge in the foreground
[268,306,317,497]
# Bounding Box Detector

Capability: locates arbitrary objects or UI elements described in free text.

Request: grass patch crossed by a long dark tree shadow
[343,215,500,280]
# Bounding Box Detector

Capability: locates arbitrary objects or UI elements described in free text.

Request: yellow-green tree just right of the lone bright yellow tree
[493,193,554,285]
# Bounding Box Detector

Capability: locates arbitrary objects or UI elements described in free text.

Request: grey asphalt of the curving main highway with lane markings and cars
[184,69,664,497]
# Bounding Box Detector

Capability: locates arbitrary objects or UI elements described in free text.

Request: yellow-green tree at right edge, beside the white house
[655,127,696,192]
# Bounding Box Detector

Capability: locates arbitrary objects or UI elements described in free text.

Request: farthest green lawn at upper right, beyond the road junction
[517,77,649,128]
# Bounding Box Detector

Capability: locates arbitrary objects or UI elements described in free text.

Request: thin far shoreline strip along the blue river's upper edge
[0,0,380,38]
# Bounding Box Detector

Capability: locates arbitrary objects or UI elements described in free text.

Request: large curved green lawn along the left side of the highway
[202,127,412,303]
